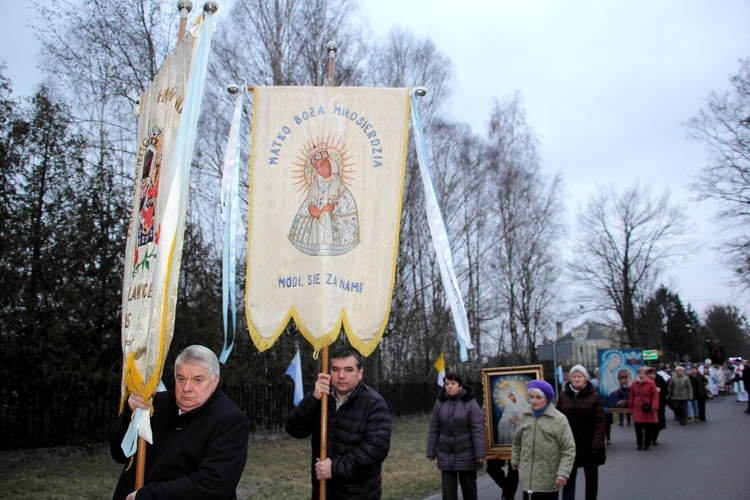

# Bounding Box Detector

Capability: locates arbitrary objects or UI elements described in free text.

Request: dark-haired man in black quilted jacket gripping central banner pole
[286,345,391,499]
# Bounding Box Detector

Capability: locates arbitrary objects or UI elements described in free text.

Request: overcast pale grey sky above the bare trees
[0,0,750,320]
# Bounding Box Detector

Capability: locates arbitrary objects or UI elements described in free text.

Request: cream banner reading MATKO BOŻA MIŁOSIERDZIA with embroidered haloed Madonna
[246,87,409,355]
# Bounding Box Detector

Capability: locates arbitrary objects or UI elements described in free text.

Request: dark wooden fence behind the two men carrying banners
[0,383,482,450]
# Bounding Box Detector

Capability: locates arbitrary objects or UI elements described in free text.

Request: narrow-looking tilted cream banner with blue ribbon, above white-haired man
[121,14,213,446]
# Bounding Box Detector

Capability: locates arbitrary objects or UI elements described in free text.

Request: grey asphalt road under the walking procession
[425,396,750,500]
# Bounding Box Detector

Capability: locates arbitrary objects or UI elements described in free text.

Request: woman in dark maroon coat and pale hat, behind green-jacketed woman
[557,365,607,500]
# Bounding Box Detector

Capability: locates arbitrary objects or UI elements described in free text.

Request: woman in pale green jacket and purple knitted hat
[510,380,576,500]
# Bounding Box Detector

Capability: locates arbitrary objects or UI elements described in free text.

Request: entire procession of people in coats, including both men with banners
[110,344,750,500]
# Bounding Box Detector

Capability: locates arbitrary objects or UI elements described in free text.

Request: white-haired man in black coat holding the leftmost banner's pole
[110,345,248,500]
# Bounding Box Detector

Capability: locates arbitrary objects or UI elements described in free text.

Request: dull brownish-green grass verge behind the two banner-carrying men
[0,415,440,500]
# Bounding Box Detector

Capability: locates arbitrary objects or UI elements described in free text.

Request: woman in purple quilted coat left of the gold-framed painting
[427,373,487,500]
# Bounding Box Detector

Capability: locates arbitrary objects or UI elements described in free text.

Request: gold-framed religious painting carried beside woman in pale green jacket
[482,365,544,460]
